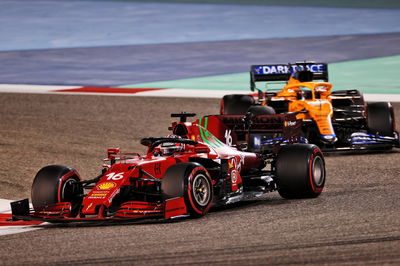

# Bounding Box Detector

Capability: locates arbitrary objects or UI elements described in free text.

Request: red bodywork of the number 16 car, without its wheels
[26,117,264,222]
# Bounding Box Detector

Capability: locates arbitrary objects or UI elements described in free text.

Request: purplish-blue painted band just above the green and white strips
[0,33,400,86]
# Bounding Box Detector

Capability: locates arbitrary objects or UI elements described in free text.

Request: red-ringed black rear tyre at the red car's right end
[275,144,326,199]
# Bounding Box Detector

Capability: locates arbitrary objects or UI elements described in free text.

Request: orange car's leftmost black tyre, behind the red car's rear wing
[221,94,255,115]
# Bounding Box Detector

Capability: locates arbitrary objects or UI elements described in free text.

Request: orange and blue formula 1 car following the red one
[221,62,399,150]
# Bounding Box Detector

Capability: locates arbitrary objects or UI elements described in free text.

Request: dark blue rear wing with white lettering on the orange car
[250,62,328,91]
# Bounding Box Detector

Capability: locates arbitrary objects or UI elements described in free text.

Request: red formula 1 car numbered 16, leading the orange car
[11,113,325,222]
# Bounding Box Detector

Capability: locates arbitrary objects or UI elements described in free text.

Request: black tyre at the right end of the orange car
[367,102,395,137]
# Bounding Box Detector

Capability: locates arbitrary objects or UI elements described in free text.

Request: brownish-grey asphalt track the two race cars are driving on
[0,94,400,265]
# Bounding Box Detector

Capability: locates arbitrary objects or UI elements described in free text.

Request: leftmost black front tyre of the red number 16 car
[31,165,83,216]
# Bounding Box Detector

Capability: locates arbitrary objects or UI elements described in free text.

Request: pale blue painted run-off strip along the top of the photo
[0,0,400,51]
